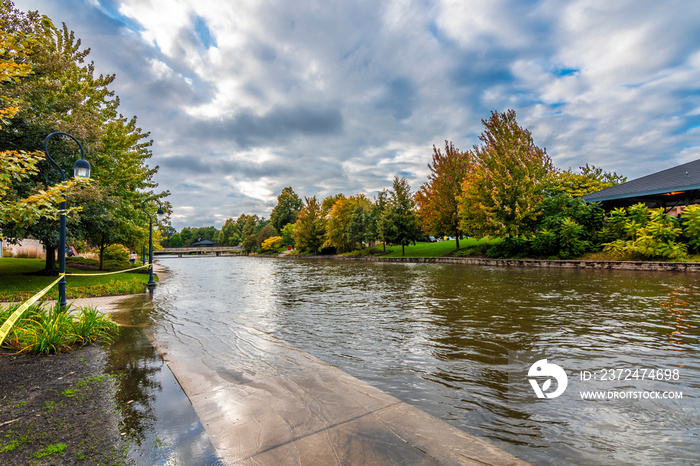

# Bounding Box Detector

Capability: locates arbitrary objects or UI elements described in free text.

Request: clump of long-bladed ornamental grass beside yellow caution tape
[0,304,119,354]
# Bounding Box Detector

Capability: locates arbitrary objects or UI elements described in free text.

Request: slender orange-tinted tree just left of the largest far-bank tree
[415,141,473,249]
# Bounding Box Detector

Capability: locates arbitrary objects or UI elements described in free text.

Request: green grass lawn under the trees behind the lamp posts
[0,257,156,302]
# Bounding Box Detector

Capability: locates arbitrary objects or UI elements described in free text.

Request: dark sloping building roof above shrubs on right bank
[583,159,700,210]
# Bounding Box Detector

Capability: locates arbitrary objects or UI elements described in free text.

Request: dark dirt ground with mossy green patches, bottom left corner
[0,345,129,465]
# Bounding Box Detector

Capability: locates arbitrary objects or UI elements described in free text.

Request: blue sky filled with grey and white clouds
[10,0,700,230]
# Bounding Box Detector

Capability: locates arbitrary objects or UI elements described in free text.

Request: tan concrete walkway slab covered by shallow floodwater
[154,322,525,465]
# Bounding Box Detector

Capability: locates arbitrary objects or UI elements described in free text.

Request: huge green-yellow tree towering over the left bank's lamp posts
[0,1,170,270]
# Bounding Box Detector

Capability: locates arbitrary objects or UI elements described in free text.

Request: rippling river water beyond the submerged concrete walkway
[146,257,700,464]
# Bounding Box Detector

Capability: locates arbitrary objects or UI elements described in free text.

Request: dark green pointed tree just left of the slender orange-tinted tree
[380,176,423,256]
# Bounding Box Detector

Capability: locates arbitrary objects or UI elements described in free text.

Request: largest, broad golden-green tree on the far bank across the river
[459,110,552,237]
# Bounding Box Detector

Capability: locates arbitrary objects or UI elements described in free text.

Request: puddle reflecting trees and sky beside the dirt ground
[106,297,223,465]
